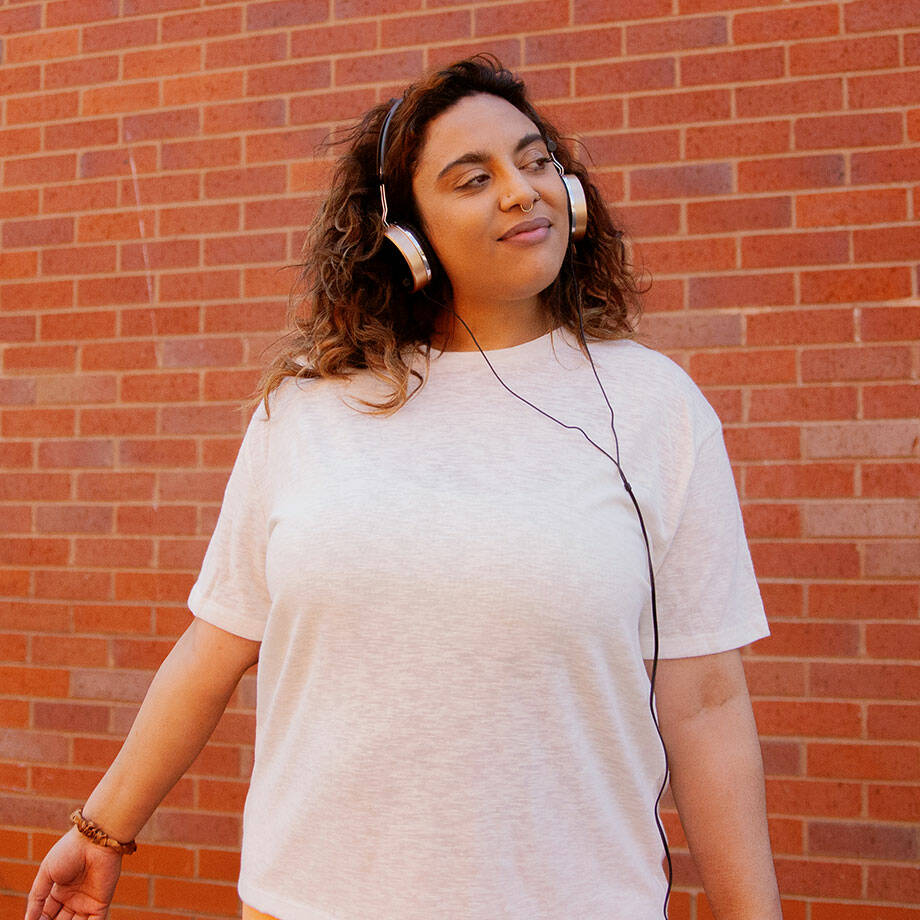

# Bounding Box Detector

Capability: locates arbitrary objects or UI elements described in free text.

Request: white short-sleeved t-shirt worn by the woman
[189,330,768,920]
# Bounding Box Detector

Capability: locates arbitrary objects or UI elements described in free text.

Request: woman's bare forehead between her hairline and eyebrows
[418,93,539,172]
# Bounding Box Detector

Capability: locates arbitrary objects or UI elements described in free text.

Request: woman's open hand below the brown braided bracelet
[25,828,121,920]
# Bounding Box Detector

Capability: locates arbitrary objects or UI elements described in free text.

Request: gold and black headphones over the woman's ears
[377,99,588,294]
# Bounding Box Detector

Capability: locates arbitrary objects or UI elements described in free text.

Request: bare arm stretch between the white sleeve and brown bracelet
[83,620,258,840]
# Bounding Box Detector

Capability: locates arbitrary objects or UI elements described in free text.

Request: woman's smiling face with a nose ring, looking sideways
[412,93,569,307]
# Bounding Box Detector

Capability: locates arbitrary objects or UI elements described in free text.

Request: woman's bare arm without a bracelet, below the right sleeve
[647,649,782,920]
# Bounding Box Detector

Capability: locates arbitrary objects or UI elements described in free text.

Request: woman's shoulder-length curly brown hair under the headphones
[253,54,644,415]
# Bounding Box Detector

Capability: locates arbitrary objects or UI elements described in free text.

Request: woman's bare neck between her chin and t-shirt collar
[431,299,552,351]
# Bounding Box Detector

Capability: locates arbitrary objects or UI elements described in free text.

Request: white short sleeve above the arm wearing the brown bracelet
[188,409,271,640]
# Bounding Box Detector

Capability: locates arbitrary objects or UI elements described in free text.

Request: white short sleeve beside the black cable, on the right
[641,426,770,658]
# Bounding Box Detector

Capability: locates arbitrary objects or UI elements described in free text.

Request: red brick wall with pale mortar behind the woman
[0,0,920,920]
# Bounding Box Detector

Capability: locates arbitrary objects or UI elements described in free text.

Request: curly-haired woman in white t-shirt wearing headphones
[26,56,780,920]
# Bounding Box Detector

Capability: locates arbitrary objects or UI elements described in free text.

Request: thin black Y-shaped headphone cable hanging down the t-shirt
[451,284,674,920]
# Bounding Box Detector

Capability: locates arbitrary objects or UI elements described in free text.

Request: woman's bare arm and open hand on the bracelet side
[25,618,259,920]
